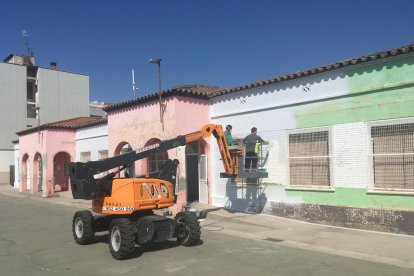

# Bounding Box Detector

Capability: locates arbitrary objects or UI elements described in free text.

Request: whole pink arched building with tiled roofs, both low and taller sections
[18,85,221,211]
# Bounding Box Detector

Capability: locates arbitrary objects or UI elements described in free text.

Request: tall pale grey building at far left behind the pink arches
[0,55,89,183]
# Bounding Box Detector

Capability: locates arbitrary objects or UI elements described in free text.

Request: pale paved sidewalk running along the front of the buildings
[0,182,414,268]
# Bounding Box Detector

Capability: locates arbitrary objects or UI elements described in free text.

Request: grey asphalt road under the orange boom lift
[0,194,414,276]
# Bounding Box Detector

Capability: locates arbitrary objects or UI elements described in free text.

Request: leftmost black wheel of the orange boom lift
[72,211,95,245]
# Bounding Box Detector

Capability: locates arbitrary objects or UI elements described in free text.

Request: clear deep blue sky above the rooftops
[0,0,414,103]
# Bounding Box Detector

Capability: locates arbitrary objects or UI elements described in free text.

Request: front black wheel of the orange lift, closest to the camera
[109,218,135,260]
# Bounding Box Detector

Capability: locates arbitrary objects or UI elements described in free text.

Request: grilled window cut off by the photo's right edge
[371,123,414,191]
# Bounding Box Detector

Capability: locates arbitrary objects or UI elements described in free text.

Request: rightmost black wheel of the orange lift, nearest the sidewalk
[174,212,201,246]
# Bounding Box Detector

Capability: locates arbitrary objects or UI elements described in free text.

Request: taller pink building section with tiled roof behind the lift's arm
[104,85,220,211]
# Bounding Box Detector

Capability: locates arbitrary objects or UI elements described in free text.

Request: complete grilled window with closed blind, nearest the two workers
[289,131,330,186]
